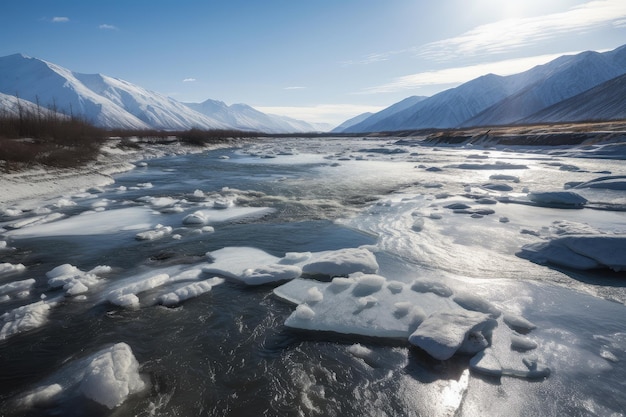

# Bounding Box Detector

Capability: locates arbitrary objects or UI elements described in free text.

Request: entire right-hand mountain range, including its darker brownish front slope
[334,45,626,133]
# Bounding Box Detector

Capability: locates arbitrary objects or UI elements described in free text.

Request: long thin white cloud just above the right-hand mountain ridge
[360,52,577,94]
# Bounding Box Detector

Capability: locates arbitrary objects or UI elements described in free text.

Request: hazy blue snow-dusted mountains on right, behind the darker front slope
[342,45,626,133]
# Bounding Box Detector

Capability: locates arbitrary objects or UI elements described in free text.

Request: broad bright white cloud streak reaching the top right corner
[419,0,626,61]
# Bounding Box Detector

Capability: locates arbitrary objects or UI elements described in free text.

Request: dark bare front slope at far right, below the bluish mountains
[520,74,626,123]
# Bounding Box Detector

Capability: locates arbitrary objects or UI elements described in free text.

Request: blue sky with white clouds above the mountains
[0,0,626,124]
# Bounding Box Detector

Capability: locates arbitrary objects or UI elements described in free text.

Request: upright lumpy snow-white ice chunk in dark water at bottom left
[80,343,145,409]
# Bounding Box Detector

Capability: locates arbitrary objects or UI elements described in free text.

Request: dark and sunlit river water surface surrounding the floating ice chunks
[0,139,626,416]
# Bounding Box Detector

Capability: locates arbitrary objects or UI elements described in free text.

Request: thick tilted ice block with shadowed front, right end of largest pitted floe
[409,310,498,360]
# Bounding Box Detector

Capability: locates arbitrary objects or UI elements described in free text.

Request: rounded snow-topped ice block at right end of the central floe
[302,248,378,277]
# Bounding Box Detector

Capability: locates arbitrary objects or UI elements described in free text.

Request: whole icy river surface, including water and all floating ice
[0,139,626,416]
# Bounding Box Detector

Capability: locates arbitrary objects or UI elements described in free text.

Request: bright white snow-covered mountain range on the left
[0,54,317,133]
